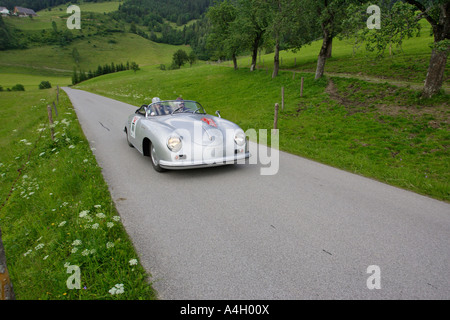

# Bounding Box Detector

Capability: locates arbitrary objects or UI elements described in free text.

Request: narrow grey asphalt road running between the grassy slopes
[64,88,450,300]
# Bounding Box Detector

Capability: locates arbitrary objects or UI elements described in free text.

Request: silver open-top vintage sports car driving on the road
[124,98,250,172]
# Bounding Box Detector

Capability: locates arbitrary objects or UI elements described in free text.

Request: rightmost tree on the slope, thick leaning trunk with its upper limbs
[405,0,450,98]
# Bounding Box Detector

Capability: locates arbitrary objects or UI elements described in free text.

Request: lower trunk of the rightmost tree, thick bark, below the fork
[422,44,450,98]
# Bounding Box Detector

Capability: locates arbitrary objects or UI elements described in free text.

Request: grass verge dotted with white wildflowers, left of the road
[0,89,156,300]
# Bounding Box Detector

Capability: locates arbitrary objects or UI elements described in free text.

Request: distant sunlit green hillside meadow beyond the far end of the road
[0,2,190,90]
